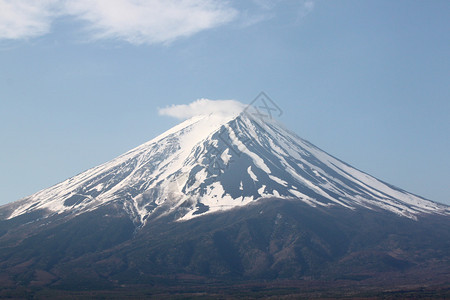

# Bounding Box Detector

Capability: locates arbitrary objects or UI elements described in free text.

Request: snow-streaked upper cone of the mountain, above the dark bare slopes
[0,105,450,225]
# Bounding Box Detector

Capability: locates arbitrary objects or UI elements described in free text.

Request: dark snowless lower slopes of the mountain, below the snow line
[0,198,450,298]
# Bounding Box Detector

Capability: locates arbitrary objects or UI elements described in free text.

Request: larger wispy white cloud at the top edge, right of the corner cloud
[66,0,237,44]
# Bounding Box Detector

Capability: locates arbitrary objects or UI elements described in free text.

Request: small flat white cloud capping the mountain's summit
[158,99,245,120]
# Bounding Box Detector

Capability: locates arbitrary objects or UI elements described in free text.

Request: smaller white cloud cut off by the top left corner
[0,0,59,39]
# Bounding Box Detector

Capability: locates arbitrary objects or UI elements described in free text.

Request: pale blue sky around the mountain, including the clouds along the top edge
[0,0,450,204]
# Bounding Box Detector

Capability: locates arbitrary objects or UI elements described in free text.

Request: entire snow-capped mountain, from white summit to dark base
[0,108,450,296]
